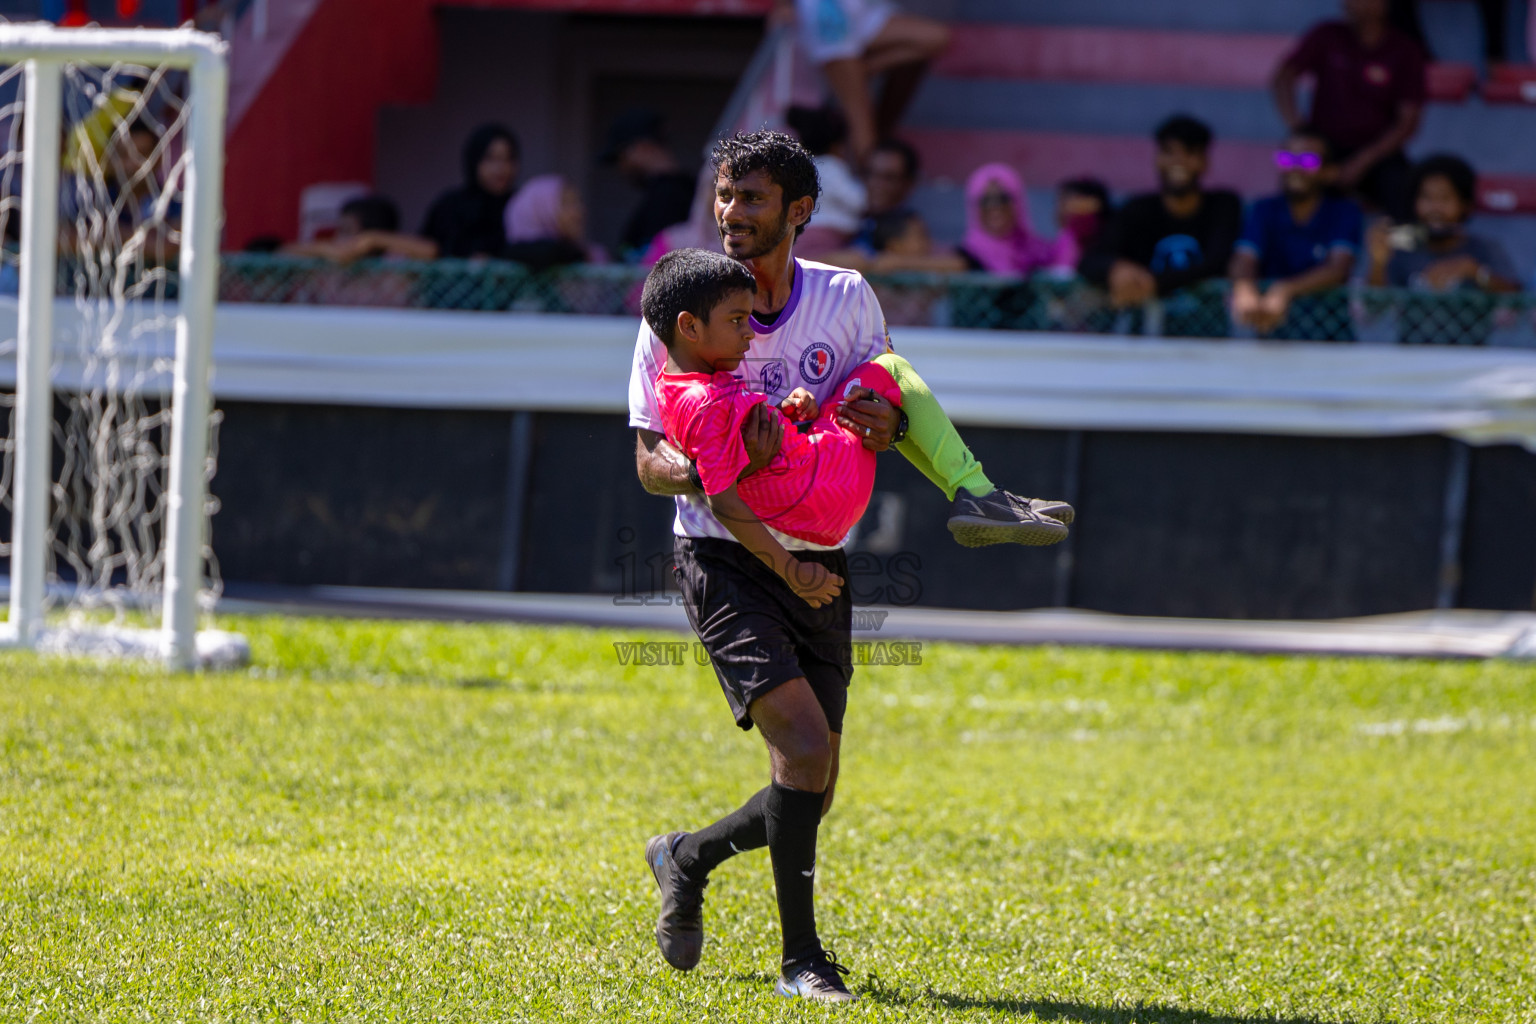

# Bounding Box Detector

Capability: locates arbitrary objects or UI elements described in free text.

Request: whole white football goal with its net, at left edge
[0,25,244,668]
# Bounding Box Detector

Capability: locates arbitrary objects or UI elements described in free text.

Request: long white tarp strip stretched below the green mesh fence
[9,299,1536,450]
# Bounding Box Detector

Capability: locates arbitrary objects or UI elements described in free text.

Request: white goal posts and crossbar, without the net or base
[0,23,229,669]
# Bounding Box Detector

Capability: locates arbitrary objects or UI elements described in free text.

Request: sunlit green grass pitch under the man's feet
[0,619,1536,1024]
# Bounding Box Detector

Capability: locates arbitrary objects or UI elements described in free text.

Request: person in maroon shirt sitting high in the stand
[1272,0,1425,220]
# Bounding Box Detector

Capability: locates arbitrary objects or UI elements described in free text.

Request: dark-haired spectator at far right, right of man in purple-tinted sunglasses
[1369,154,1521,345]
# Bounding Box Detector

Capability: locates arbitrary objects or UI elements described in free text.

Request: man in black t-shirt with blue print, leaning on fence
[1078,115,1243,320]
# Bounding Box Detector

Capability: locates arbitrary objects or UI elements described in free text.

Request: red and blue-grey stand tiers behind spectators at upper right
[906,0,1536,275]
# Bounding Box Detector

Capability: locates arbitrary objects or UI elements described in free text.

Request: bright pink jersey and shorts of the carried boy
[656,362,902,545]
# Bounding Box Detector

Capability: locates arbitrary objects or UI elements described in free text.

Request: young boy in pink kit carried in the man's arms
[641,249,1072,608]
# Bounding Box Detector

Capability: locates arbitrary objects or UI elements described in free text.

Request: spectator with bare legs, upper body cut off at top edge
[777,0,949,166]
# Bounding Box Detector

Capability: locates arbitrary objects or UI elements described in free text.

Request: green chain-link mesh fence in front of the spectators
[220,253,1536,347]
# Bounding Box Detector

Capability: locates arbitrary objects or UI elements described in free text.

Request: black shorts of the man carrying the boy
[673,537,854,732]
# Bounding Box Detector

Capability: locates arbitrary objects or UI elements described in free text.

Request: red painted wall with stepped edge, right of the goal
[224,0,438,249]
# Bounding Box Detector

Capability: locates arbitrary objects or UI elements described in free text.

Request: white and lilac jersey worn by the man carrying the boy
[630,259,888,550]
